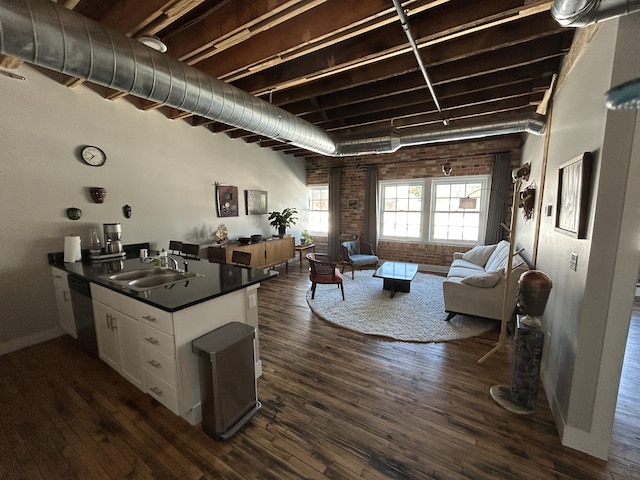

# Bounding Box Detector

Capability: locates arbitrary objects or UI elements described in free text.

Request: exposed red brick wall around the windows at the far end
[307,135,522,266]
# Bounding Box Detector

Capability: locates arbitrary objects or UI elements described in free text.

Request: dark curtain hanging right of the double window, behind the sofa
[484,152,511,245]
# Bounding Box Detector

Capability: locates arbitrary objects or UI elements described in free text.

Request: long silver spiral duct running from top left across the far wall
[0,0,544,156]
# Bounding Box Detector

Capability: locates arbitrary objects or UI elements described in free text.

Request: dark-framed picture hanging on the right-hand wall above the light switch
[555,152,592,238]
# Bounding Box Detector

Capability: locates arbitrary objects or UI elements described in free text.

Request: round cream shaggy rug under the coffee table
[307,270,497,342]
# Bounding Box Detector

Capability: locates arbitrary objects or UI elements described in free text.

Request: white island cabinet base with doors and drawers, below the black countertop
[91,283,262,425]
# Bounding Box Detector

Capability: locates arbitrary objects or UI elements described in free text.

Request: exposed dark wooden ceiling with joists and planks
[53,0,574,161]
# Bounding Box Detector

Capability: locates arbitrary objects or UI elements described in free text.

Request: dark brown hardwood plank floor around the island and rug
[0,262,640,480]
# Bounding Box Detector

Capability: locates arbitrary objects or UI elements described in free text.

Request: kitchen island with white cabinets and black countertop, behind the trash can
[49,254,278,425]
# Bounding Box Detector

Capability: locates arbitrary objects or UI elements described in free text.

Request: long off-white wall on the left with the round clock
[0,66,306,354]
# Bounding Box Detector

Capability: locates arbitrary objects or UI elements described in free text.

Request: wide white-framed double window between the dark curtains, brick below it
[380,175,490,244]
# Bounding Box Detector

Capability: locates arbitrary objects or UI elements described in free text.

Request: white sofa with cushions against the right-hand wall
[442,240,529,320]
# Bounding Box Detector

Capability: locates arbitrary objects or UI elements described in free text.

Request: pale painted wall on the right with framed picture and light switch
[518,14,640,458]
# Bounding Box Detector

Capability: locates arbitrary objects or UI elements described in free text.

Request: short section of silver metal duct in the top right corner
[551,0,640,27]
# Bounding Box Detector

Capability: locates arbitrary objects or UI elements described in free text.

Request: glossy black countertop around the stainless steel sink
[49,254,278,312]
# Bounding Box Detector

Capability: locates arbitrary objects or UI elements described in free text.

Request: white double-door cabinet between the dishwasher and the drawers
[93,300,144,390]
